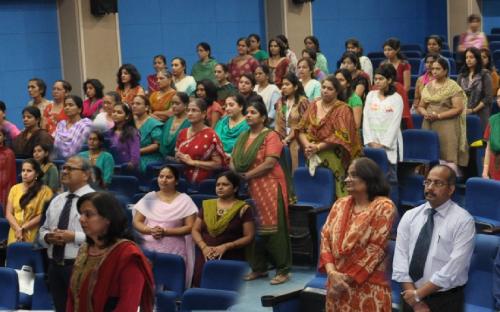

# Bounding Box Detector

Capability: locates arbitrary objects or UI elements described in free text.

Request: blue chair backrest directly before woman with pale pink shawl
[153,252,186,296]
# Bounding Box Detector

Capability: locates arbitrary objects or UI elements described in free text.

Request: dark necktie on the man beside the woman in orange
[409,208,437,282]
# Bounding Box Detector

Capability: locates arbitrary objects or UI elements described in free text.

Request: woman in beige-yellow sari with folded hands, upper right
[418,58,469,175]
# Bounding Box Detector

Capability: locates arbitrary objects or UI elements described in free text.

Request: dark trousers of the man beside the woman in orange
[401,286,465,312]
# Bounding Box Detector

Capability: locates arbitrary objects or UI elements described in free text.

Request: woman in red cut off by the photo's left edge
[0,129,17,210]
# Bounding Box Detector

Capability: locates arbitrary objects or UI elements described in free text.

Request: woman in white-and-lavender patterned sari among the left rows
[54,95,92,159]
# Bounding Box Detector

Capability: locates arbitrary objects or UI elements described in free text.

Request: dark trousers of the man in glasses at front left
[49,260,74,312]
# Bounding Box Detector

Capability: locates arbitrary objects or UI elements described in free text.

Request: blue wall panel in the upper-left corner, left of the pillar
[0,0,61,128]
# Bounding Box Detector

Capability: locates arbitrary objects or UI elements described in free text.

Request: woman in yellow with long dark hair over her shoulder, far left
[5,158,52,244]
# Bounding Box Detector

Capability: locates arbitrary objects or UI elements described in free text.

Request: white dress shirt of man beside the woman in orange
[392,200,476,291]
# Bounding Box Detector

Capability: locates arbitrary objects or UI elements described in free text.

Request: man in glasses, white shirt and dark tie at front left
[40,156,94,312]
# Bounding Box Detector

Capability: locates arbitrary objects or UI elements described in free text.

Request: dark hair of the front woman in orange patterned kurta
[353,157,391,201]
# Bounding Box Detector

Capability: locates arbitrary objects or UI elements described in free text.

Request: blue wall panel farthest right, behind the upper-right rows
[312,0,447,71]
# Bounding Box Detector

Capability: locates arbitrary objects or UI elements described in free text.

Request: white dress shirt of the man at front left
[38,184,95,259]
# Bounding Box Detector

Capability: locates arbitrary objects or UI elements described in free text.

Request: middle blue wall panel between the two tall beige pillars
[119,0,267,85]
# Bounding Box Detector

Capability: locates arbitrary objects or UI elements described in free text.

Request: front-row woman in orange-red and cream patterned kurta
[319,157,396,312]
